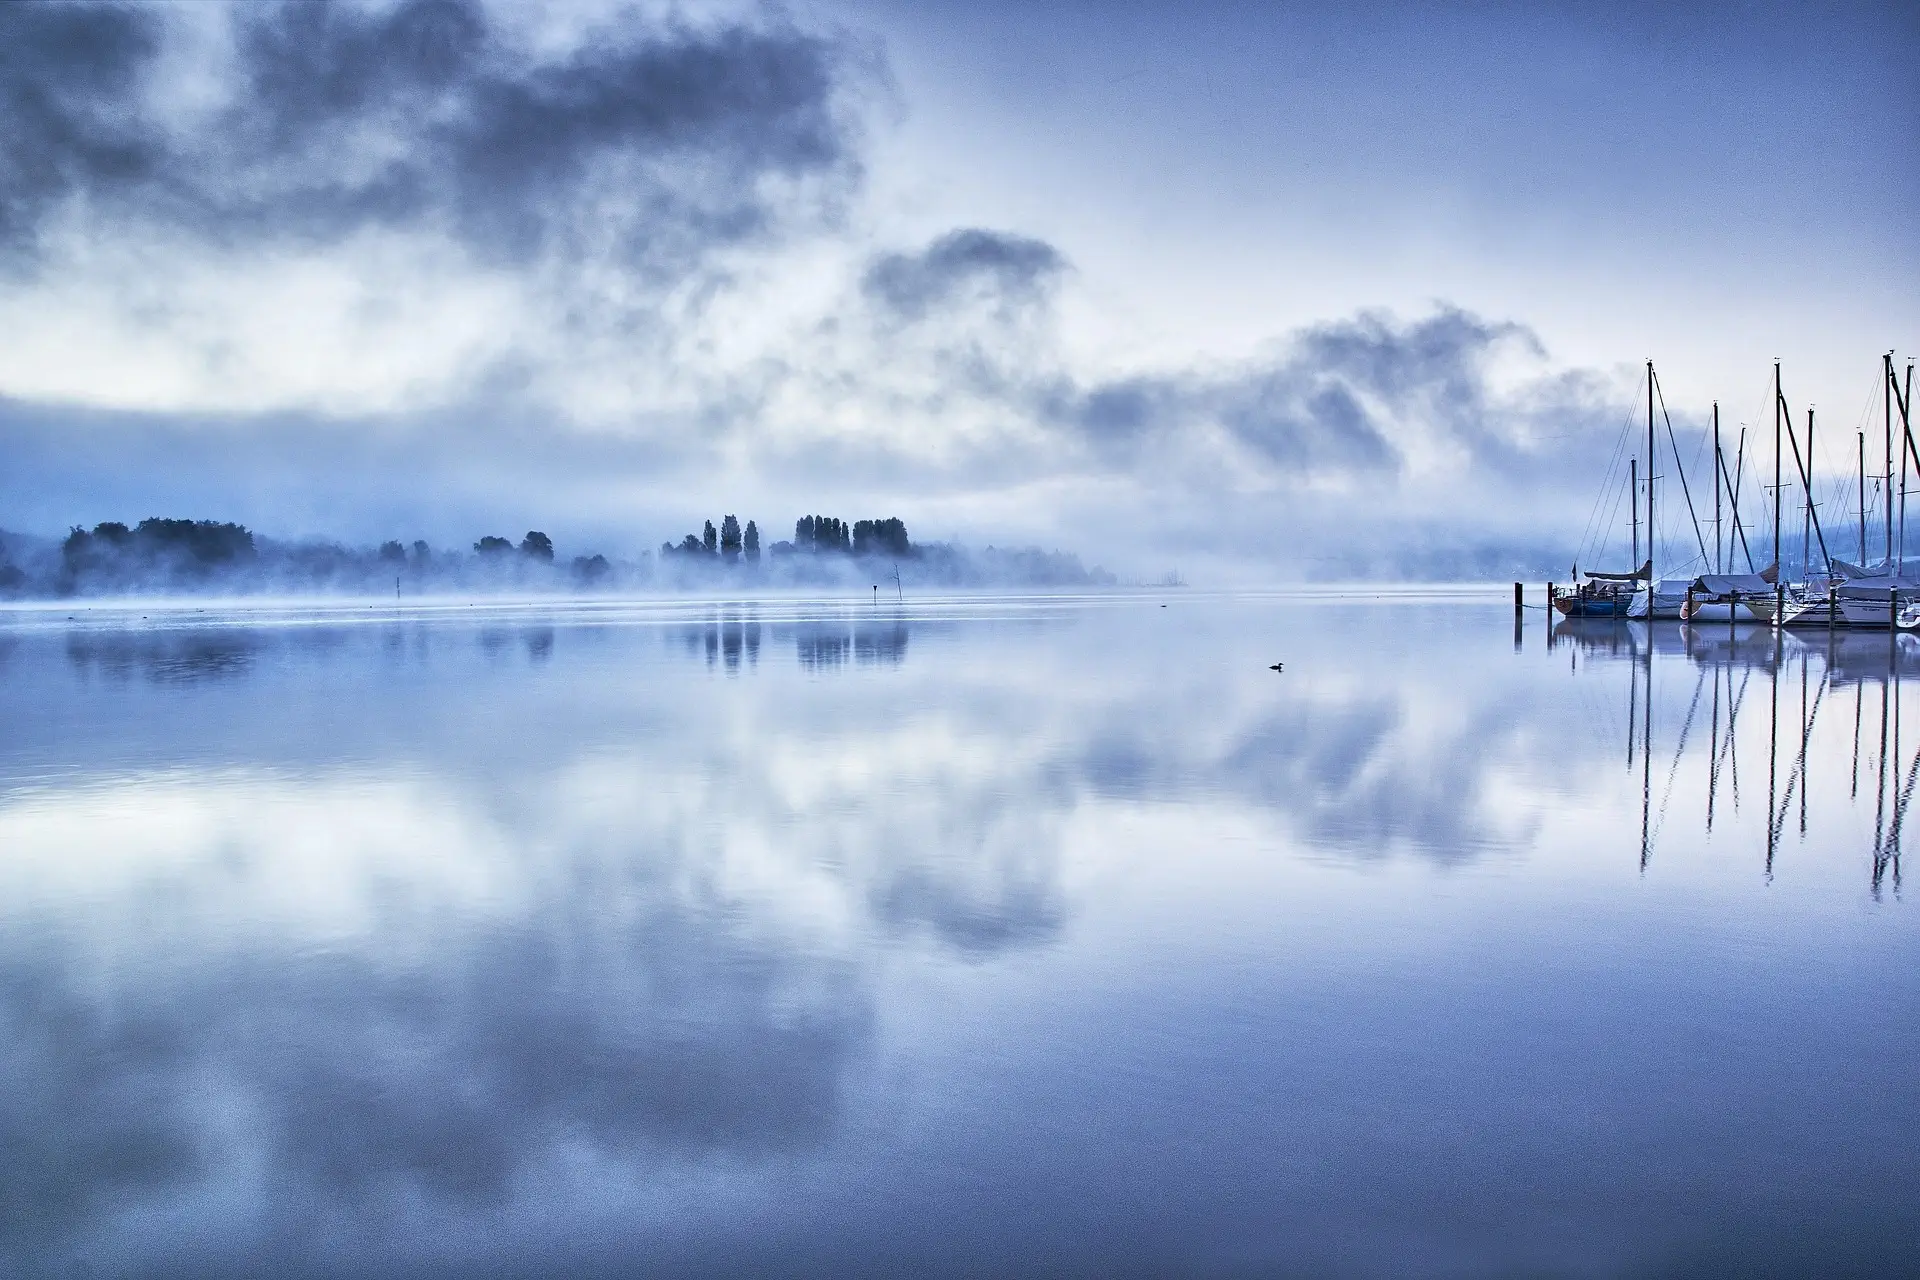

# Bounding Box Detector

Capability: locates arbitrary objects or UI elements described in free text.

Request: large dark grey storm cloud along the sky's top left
[0,0,856,263]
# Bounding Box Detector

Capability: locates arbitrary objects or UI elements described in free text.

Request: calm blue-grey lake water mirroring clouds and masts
[0,591,1920,1276]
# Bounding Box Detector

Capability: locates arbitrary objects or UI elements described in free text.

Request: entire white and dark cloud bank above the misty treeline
[0,0,1635,562]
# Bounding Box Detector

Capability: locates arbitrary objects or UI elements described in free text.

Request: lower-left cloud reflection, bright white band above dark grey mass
[0,775,870,1245]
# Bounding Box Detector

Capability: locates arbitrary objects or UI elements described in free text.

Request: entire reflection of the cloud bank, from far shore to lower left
[0,603,1589,1257]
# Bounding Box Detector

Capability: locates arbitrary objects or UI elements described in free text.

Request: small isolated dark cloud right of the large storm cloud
[860,226,1068,320]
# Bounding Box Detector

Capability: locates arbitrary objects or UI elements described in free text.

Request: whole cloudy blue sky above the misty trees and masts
[0,0,1920,578]
